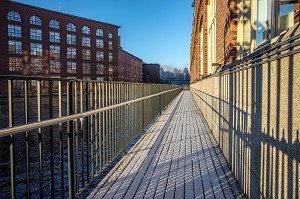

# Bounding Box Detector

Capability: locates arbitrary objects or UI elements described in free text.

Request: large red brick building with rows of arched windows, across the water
[0,0,120,81]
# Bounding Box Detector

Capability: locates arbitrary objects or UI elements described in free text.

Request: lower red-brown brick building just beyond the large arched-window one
[117,49,143,82]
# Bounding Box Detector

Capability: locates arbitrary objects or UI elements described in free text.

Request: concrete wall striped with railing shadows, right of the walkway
[191,25,300,198]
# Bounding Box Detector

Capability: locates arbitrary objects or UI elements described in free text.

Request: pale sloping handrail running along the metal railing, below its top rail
[0,87,181,138]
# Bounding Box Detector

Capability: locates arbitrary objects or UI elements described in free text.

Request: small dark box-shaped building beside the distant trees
[143,63,160,84]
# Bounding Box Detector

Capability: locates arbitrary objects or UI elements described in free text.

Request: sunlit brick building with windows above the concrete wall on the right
[190,0,300,83]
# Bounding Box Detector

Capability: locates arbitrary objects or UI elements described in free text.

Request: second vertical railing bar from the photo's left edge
[24,80,31,198]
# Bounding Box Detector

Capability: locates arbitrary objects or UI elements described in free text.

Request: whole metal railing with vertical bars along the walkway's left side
[0,76,183,198]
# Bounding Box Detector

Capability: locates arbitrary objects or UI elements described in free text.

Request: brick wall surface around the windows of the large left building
[0,0,120,80]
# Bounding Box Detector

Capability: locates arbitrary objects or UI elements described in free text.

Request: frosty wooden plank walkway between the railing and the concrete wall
[88,91,244,199]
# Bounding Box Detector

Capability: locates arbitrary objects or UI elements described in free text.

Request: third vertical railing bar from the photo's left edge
[37,80,44,198]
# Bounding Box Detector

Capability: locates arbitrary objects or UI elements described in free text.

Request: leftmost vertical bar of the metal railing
[7,80,16,199]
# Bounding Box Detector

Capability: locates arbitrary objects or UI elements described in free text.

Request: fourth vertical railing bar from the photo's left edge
[49,80,55,198]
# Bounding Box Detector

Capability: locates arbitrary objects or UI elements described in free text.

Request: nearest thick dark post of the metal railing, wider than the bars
[67,81,75,198]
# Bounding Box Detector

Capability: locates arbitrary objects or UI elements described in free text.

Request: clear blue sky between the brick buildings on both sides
[16,0,193,69]
